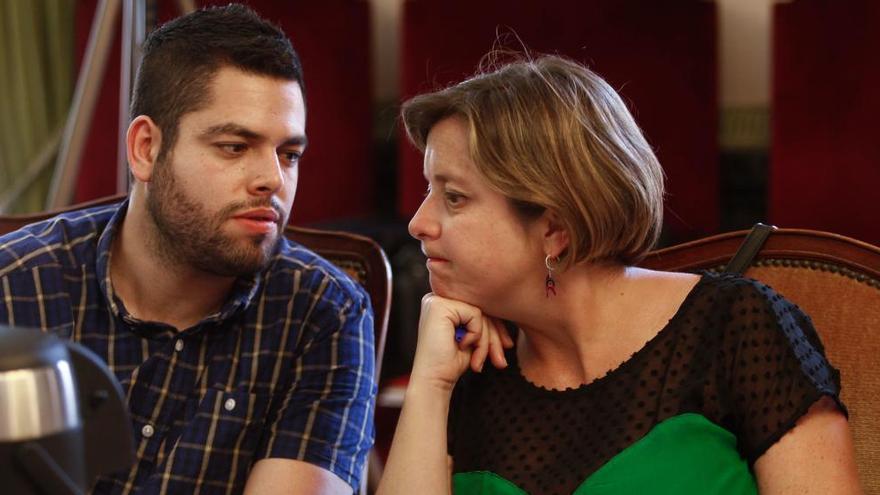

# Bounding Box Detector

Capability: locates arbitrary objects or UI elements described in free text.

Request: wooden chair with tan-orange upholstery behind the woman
[640,229,880,494]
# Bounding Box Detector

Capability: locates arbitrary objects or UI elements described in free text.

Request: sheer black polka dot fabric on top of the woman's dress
[449,273,845,494]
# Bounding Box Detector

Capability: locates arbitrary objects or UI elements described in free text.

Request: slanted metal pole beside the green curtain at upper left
[46,0,120,210]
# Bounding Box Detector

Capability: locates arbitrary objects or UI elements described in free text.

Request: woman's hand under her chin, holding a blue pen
[410,293,513,390]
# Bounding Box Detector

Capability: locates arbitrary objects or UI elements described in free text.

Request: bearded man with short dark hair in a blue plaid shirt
[0,5,375,494]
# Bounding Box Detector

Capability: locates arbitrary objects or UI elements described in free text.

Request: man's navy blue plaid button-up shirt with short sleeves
[0,202,376,494]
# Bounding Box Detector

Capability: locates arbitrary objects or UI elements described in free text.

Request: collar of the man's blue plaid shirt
[95,198,263,330]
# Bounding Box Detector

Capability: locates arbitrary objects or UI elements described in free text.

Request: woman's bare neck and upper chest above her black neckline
[517,265,699,388]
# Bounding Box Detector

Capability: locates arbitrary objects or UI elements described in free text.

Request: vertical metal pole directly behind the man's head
[116,0,146,194]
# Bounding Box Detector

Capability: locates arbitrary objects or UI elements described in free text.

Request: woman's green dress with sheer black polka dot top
[449,273,845,495]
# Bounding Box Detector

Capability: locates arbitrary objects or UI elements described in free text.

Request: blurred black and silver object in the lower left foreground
[0,325,134,495]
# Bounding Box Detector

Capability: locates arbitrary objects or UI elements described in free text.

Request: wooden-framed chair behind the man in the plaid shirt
[0,196,391,493]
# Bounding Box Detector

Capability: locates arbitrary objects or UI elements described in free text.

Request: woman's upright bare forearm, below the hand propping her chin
[376,377,452,495]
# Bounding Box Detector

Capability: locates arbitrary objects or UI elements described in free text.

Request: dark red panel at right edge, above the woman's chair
[769,0,880,244]
